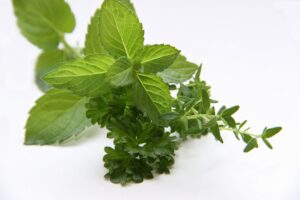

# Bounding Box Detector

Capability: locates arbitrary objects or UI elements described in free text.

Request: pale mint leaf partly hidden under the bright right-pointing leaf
[157,55,198,83]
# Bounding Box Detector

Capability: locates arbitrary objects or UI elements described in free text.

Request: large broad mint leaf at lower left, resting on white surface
[25,89,90,145]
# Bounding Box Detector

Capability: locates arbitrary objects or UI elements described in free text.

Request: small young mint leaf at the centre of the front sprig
[106,57,134,87]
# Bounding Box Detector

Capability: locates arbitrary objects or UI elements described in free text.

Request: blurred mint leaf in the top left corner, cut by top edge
[13,0,75,49]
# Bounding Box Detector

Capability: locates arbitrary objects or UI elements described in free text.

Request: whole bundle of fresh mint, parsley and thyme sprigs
[13,0,281,185]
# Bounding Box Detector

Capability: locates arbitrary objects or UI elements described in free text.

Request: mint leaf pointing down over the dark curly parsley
[134,73,171,123]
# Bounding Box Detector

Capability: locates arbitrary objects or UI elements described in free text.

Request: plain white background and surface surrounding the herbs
[0,0,300,200]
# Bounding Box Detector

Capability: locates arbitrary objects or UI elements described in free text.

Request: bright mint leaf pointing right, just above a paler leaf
[142,44,179,73]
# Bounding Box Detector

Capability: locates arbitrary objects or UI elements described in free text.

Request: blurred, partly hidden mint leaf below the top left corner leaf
[35,49,67,92]
